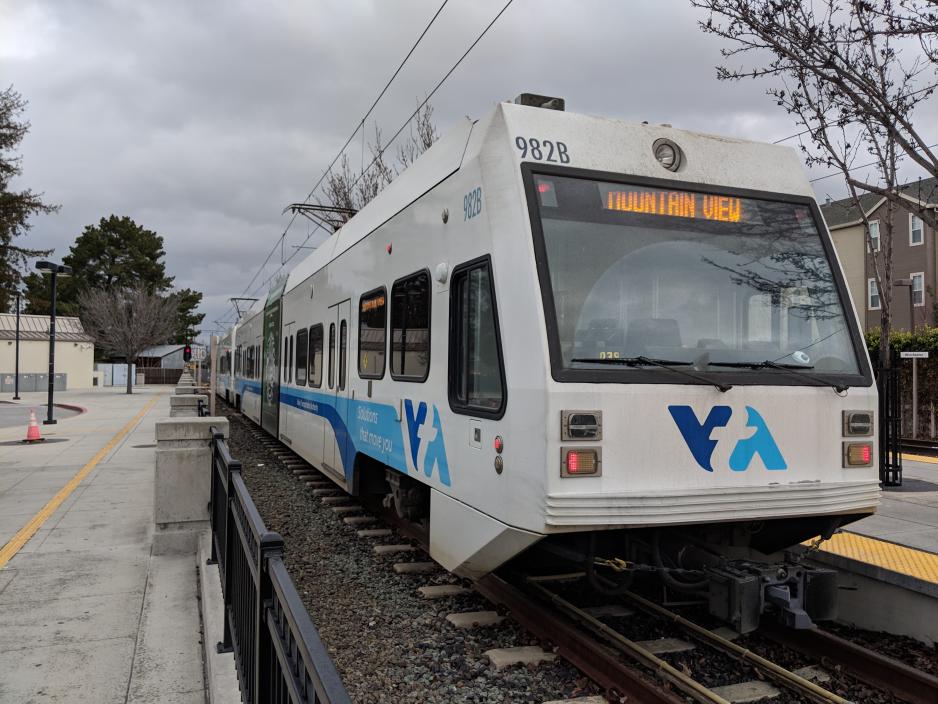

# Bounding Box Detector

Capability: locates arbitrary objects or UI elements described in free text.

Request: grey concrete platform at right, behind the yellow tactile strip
[845,458,938,553]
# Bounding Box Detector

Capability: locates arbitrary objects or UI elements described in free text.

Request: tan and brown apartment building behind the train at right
[821,178,938,330]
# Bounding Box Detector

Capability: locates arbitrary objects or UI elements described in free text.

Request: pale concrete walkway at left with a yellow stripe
[0,387,205,704]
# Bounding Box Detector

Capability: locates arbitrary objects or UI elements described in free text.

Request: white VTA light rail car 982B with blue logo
[232,97,880,575]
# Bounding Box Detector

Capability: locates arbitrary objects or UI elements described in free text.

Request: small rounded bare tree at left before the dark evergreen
[79,288,177,394]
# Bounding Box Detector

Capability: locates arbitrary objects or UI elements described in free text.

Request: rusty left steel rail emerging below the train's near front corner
[474,574,680,704]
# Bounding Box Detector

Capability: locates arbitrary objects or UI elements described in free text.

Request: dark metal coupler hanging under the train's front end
[706,560,837,633]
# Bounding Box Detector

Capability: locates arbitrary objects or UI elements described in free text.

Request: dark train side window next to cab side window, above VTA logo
[391,271,430,382]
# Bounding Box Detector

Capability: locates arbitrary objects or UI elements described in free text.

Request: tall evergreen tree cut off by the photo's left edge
[0,86,59,311]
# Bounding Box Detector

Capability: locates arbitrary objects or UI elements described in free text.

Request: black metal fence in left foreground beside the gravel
[208,426,351,704]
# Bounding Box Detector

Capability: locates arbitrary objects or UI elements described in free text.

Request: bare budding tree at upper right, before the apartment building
[691,0,938,366]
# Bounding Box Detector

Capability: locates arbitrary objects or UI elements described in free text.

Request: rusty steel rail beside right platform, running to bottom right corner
[759,624,938,704]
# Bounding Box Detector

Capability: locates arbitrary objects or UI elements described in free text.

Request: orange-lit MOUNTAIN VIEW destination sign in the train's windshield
[600,184,746,222]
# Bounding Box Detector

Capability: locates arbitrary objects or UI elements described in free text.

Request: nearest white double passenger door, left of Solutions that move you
[323,299,352,478]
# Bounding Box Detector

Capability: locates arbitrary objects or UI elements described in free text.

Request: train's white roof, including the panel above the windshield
[280,102,814,294]
